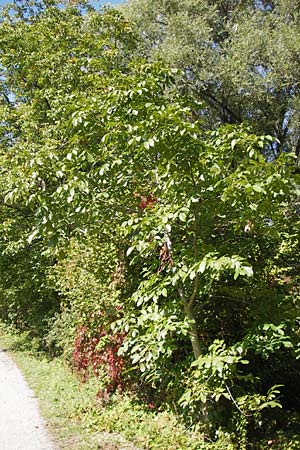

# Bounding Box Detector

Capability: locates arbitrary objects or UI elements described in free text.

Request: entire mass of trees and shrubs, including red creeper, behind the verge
[0,0,300,449]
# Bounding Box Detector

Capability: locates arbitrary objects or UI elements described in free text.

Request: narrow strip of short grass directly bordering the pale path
[0,331,97,450]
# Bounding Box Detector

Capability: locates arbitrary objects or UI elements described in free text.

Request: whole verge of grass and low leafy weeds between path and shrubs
[0,327,213,450]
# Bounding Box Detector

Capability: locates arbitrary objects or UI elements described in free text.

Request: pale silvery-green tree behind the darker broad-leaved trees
[124,0,300,156]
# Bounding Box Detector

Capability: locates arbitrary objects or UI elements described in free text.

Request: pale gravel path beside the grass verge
[0,349,56,450]
